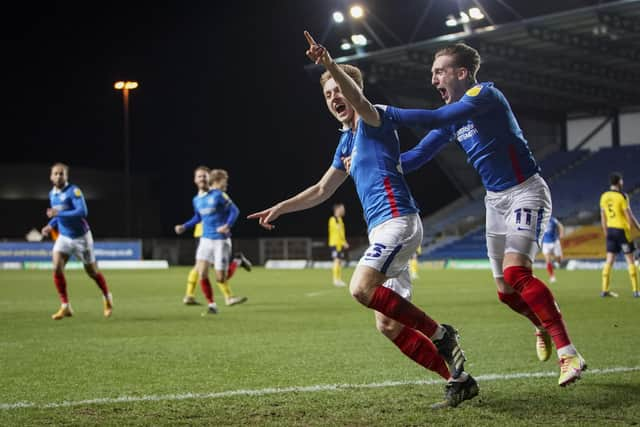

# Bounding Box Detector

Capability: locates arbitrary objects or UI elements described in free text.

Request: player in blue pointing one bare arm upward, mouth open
[248,31,478,407]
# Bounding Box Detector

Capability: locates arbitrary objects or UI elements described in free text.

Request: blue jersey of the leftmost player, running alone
[49,184,89,239]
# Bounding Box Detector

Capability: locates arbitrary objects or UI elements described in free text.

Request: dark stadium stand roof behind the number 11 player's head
[308,0,640,114]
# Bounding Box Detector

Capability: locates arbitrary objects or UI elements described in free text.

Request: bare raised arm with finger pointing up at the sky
[304,31,381,127]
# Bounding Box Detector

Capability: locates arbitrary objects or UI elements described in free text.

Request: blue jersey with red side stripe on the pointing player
[332,107,418,229]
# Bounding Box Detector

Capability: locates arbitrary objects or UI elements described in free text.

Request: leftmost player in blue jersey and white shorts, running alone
[41,163,113,320]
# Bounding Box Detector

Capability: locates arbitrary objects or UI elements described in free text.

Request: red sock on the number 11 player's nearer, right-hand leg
[504,266,571,348]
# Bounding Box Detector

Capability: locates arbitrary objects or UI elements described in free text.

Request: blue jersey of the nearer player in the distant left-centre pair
[191,189,240,239]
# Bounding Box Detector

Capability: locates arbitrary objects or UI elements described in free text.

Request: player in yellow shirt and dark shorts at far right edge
[600,173,640,298]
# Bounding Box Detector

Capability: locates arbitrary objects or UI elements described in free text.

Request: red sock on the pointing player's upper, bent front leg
[369,285,438,337]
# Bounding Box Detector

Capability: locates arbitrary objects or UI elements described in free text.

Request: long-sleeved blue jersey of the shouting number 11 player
[390,83,540,191]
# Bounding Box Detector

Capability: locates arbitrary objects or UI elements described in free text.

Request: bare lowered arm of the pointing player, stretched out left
[247,166,347,230]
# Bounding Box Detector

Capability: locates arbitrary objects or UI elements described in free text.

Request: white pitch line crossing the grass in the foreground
[0,366,640,411]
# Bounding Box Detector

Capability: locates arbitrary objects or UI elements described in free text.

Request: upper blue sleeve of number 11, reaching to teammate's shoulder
[387,86,496,129]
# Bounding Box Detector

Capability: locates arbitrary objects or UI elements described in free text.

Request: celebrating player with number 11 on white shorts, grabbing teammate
[378,43,586,386]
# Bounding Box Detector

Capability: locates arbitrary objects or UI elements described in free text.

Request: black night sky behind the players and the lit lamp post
[0,0,616,236]
